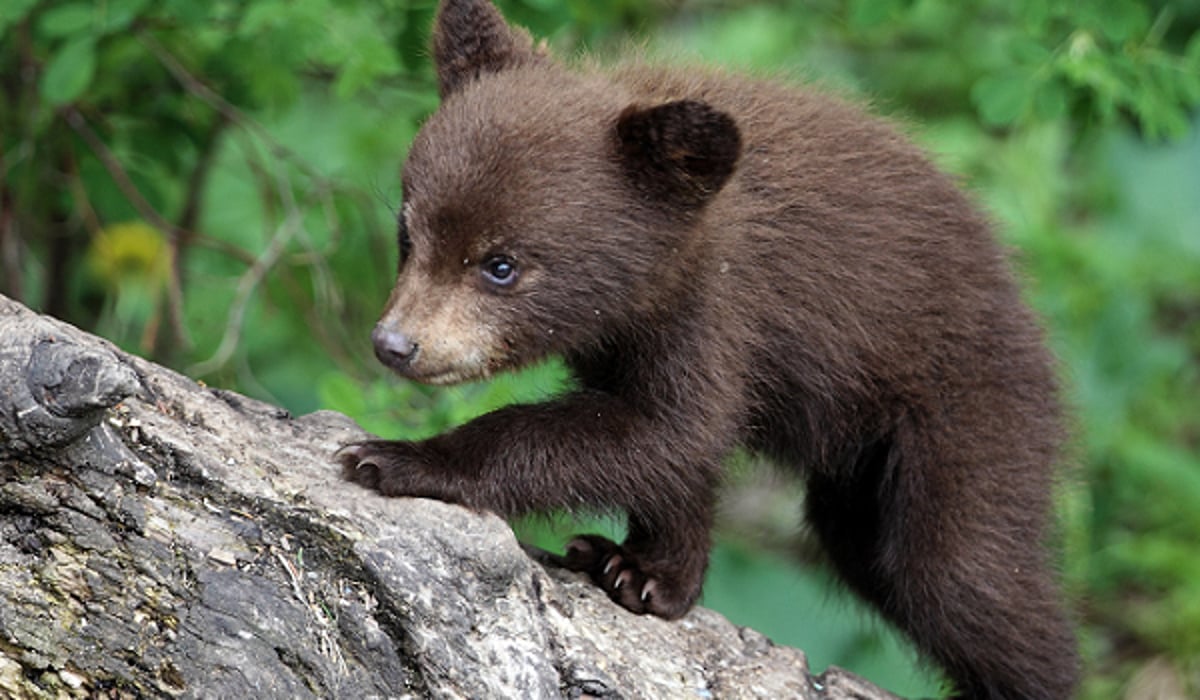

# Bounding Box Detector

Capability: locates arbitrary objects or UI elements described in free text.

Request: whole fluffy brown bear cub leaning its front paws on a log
[340,0,1076,700]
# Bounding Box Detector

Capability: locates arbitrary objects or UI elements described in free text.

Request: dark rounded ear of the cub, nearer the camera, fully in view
[617,100,742,210]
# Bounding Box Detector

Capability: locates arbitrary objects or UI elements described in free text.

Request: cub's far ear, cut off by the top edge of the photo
[433,0,544,100]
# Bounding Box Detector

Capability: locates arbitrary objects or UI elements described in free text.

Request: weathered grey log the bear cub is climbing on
[0,297,894,699]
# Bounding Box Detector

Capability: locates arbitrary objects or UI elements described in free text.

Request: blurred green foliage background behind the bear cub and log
[0,0,1200,699]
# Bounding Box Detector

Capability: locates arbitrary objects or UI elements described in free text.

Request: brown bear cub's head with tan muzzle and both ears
[372,0,742,384]
